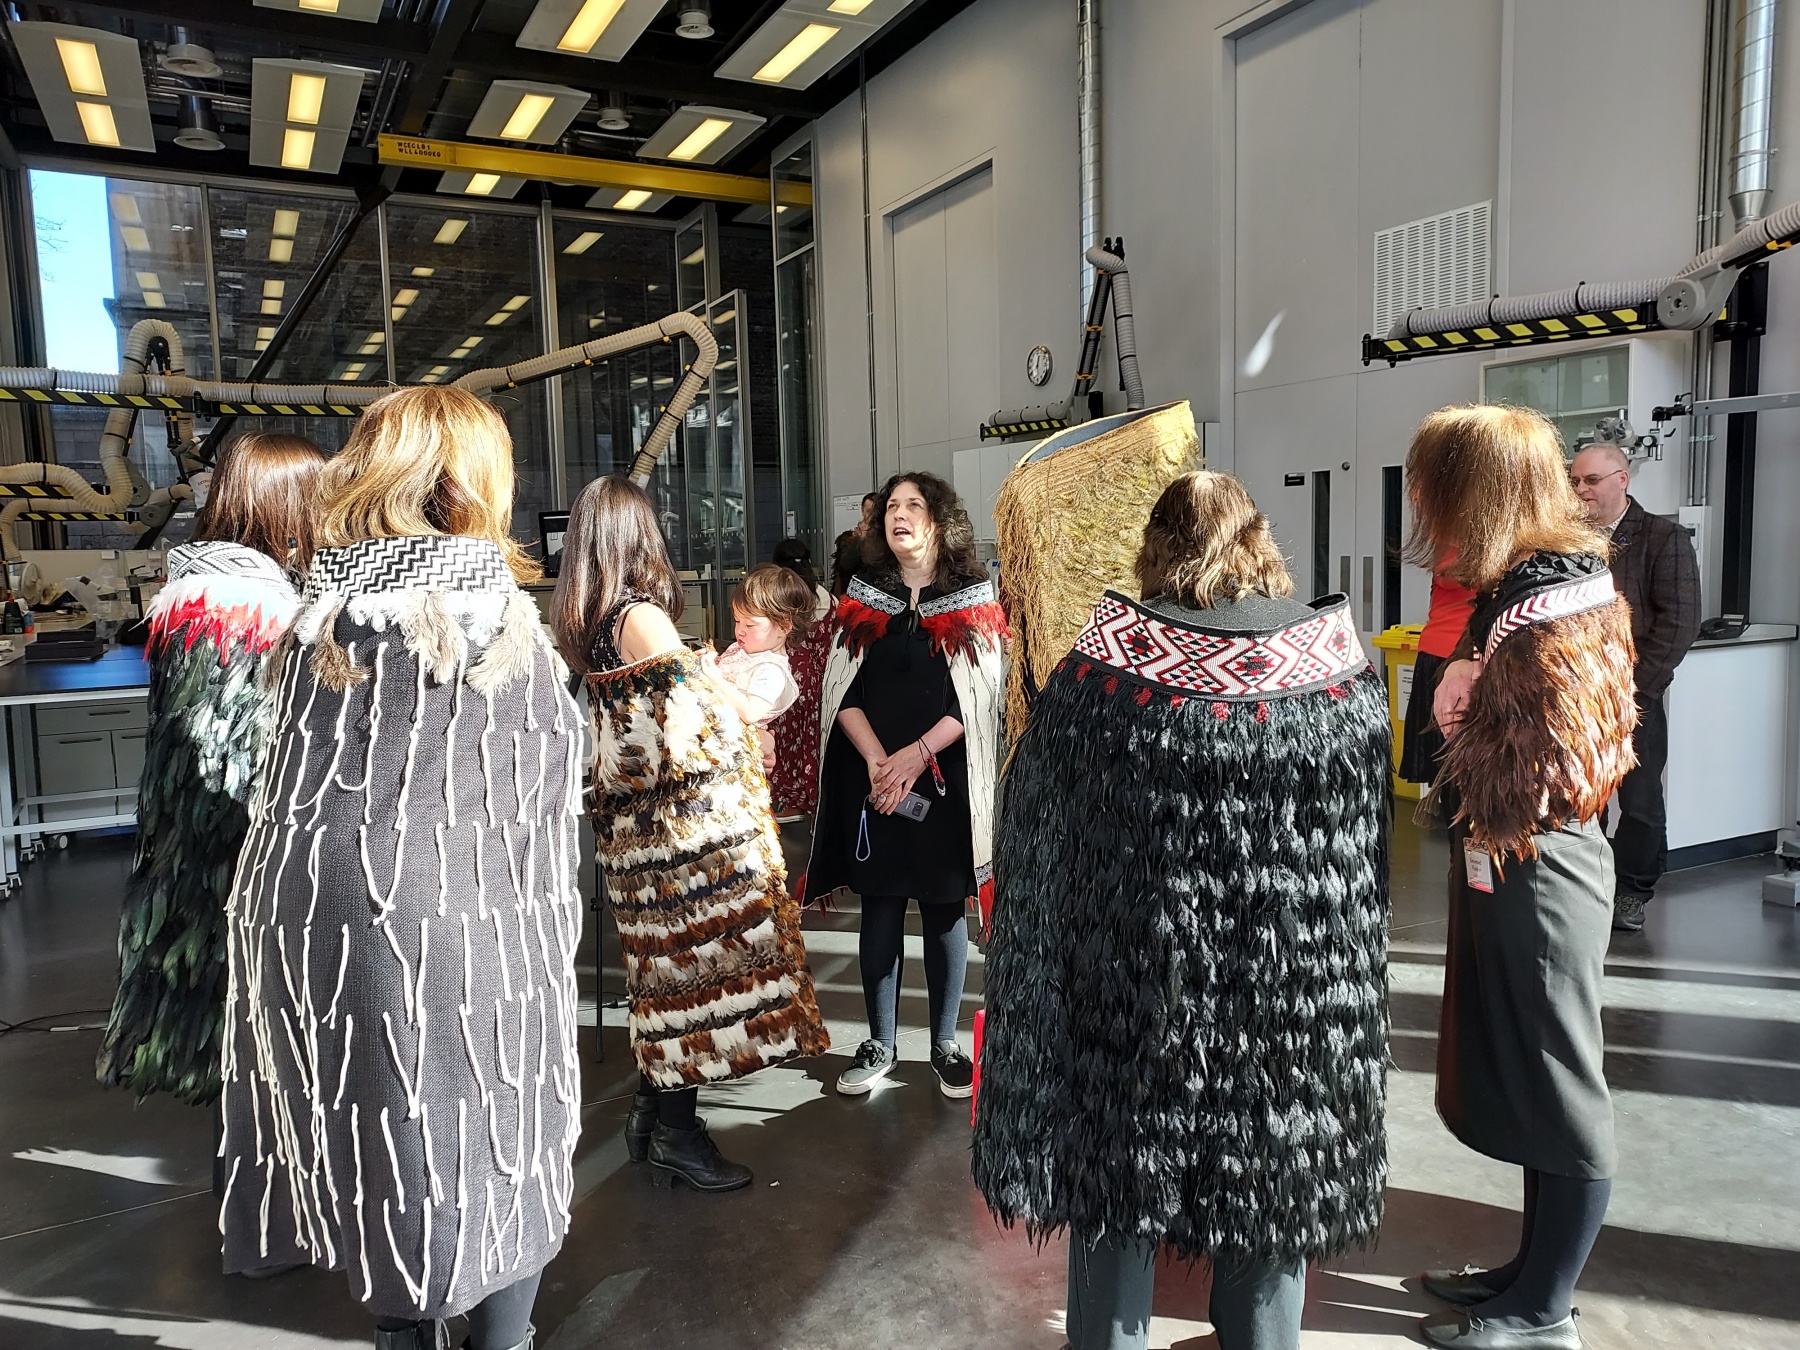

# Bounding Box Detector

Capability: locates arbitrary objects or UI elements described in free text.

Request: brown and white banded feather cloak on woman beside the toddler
[587,652,832,1087]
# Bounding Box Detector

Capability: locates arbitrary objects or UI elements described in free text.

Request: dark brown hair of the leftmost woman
[193,432,326,572]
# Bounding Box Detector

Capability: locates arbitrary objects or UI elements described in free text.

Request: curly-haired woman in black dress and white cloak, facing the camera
[805,473,1006,1098]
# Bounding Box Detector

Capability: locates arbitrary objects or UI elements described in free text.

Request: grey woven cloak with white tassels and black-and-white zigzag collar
[220,536,581,1319]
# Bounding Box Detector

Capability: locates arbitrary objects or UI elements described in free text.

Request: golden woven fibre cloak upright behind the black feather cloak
[994,400,1201,740]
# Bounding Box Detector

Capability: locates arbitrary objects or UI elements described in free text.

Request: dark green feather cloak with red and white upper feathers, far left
[95,542,299,1105]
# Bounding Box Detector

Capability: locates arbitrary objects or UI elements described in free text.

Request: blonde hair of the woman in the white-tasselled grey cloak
[317,385,542,581]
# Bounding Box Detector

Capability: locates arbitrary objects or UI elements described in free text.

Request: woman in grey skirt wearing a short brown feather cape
[1406,407,1638,1350]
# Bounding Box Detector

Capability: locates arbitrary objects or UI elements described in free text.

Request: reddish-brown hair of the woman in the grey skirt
[1406,403,1607,590]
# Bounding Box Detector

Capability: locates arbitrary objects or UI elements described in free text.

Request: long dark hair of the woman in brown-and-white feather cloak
[551,477,684,675]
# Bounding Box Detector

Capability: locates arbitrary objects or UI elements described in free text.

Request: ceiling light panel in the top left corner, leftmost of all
[7,23,157,153]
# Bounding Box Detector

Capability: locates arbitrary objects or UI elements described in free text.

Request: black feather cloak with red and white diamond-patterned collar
[974,592,1390,1262]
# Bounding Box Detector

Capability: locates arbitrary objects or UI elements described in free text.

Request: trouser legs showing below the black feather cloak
[1069,1233,1307,1350]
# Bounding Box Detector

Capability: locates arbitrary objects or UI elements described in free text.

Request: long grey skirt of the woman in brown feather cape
[1438,821,1618,1179]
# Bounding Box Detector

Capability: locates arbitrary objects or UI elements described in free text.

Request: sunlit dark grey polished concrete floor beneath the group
[0,823,1800,1350]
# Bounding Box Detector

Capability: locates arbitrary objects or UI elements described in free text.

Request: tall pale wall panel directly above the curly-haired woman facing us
[889,169,999,481]
